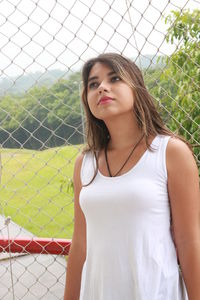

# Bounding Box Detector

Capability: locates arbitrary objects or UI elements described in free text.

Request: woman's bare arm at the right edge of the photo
[167,138,200,300]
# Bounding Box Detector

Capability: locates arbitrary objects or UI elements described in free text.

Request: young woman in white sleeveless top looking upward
[64,53,200,300]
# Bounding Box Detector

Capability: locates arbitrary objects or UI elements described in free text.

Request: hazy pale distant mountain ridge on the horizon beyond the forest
[0,54,163,96]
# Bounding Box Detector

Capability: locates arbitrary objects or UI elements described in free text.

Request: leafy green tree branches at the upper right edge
[154,10,200,160]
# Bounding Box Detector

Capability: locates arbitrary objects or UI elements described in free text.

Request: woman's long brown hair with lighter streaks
[82,53,173,157]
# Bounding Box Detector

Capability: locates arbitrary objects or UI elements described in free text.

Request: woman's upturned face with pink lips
[87,62,134,121]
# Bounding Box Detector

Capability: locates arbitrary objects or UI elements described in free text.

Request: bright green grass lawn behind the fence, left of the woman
[0,146,80,238]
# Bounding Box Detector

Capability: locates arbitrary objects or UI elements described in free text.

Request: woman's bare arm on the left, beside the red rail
[64,155,86,300]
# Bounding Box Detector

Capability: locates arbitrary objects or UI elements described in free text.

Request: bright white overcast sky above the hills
[0,0,200,78]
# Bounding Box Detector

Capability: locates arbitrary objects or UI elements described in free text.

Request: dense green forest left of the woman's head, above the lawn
[0,72,83,149]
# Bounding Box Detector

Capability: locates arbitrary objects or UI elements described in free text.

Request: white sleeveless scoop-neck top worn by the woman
[79,135,188,300]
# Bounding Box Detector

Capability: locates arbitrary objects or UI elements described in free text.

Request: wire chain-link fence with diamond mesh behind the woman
[0,0,200,300]
